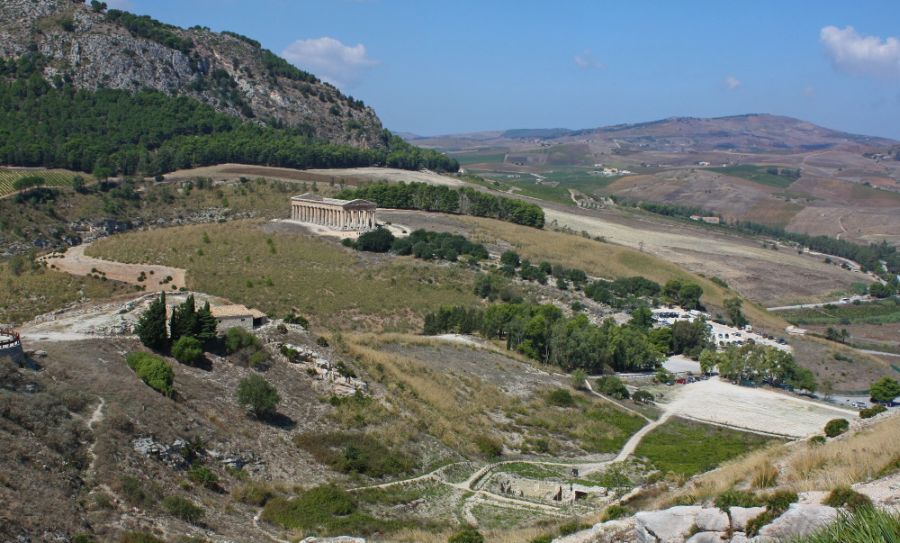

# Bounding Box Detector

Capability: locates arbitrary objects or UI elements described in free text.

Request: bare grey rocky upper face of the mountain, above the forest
[0,0,384,147]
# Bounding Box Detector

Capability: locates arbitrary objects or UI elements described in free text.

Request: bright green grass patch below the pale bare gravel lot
[635,419,775,476]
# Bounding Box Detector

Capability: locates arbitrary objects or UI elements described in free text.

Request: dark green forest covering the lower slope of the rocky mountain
[0,61,459,179]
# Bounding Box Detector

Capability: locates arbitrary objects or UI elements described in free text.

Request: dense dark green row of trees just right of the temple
[337,181,544,228]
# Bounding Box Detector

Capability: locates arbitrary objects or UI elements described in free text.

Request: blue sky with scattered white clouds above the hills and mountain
[107,0,900,139]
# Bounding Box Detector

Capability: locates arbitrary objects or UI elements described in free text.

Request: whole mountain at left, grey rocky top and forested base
[0,0,457,177]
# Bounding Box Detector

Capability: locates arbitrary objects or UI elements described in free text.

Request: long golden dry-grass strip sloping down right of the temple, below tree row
[461,217,787,330]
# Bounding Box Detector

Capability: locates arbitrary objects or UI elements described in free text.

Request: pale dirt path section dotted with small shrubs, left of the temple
[42,244,187,290]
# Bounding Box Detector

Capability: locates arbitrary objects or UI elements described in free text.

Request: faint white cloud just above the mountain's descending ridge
[281,36,378,87]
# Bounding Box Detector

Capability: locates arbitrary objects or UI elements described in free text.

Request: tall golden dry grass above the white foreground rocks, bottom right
[651,415,900,507]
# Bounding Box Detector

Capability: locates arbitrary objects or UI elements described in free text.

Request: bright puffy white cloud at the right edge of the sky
[819,26,900,78]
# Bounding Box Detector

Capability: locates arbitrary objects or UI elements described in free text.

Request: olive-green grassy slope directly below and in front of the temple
[88,221,477,331]
